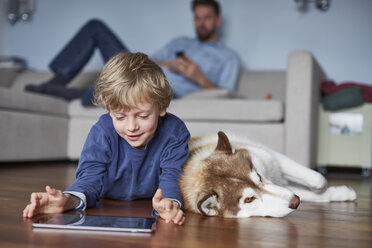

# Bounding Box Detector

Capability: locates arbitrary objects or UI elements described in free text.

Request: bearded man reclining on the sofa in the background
[25,0,240,106]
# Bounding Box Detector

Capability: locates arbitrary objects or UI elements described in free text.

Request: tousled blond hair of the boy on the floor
[94,52,173,111]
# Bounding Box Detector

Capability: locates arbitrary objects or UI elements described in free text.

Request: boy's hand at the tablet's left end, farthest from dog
[23,186,77,218]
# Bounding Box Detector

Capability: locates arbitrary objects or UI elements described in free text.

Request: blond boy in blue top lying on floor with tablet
[23,53,190,225]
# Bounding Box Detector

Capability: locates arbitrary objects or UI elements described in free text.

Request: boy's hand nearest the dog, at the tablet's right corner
[152,189,185,225]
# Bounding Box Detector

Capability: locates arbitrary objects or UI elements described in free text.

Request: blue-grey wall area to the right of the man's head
[221,0,372,84]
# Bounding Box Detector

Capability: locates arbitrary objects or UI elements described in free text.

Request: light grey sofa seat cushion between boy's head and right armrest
[168,99,284,122]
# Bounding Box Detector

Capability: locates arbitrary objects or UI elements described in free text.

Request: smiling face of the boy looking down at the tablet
[110,103,166,149]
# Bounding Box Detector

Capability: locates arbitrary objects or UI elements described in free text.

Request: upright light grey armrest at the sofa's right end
[284,51,325,168]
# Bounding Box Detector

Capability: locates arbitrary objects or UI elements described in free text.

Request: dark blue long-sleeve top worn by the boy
[67,113,190,208]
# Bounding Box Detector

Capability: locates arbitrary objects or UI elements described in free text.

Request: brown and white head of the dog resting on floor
[189,132,299,217]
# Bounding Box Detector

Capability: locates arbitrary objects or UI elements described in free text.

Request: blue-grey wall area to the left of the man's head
[6,0,193,70]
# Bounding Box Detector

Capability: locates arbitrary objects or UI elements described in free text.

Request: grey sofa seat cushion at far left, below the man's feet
[0,88,67,116]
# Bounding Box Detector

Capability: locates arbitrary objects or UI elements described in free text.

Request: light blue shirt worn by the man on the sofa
[151,37,240,97]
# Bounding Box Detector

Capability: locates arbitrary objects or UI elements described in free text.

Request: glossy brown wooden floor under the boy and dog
[0,162,372,248]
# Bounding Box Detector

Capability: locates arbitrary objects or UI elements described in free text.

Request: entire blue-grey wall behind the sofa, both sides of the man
[4,0,372,85]
